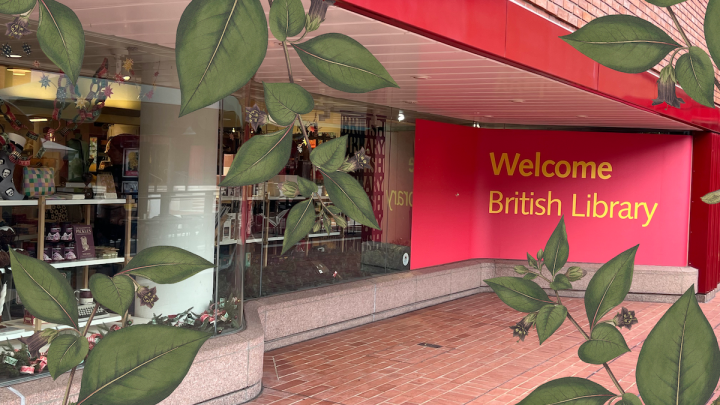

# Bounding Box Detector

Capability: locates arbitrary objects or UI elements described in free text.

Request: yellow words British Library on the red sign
[489,191,658,228]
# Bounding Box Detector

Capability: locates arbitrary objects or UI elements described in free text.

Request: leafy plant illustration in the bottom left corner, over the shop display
[10,246,213,405]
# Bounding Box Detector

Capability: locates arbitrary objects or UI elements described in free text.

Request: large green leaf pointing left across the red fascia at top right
[560,15,680,73]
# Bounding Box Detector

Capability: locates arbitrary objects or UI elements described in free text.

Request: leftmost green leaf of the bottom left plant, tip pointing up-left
[10,249,78,329]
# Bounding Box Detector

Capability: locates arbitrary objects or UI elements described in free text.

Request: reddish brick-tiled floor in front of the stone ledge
[252,293,720,405]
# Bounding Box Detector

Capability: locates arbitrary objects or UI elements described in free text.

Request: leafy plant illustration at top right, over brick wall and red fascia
[561,0,720,204]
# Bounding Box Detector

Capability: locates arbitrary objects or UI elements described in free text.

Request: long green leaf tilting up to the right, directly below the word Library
[585,245,640,329]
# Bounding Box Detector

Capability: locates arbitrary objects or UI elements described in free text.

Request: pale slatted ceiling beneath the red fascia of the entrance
[0,0,696,130]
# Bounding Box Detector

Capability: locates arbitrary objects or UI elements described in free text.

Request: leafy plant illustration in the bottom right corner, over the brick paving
[485,218,720,405]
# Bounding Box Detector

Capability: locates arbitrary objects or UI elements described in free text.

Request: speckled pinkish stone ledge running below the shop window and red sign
[0,259,696,405]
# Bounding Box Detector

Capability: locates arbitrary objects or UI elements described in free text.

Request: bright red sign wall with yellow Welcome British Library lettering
[412,121,692,268]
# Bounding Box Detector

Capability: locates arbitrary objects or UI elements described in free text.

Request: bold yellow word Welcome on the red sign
[490,152,612,180]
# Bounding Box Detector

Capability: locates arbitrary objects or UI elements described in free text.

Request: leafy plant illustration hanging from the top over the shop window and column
[175,0,398,253]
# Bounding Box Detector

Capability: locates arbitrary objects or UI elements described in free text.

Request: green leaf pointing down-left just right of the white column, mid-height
[220,126,293,187]
